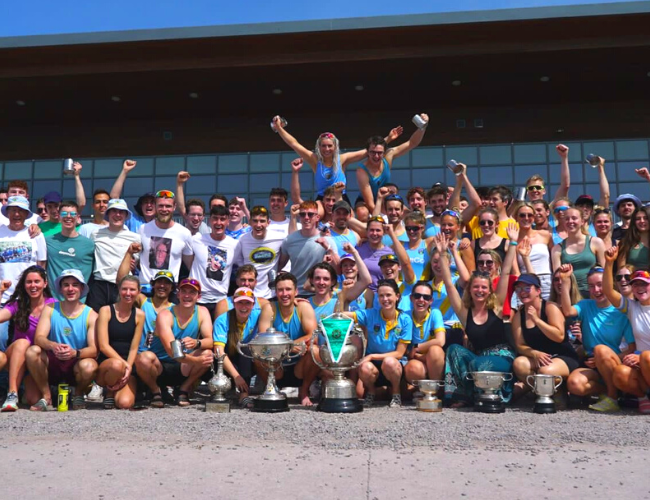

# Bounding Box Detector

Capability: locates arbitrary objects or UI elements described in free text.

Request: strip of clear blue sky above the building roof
[0,0,636,37]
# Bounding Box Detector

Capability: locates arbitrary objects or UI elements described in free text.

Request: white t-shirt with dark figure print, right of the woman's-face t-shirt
[190,233,237,304]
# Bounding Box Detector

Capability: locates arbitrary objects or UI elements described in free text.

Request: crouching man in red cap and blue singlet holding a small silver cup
[135,278,214,408]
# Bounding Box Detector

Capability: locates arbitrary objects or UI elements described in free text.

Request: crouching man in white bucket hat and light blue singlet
[25,269,97,411]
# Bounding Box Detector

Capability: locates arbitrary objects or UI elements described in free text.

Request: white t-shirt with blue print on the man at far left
[0,226,47,304]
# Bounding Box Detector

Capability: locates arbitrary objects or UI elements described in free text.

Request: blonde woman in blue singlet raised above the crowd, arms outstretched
[273,116,402,206]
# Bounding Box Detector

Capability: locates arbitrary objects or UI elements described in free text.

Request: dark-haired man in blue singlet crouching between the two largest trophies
[258,274,319,406]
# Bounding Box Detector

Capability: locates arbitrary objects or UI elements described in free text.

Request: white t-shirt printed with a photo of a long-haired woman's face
[138,220,192,284]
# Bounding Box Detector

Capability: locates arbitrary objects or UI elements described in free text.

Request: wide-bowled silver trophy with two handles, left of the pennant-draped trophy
[237,327,307,413]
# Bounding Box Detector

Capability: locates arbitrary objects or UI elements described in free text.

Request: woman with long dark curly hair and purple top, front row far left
[0,266,56,412]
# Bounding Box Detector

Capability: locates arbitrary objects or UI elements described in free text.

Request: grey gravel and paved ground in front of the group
[0,398,650,500]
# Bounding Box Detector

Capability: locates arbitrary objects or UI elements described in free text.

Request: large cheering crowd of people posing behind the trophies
[0,114,650,414]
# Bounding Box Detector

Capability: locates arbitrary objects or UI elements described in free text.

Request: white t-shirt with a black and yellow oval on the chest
[235,229,286,299]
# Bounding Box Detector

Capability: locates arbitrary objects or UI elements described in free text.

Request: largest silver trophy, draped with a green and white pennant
[311,313,366,413]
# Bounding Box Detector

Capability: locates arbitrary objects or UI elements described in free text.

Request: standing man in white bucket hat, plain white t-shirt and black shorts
[88,199,141,312]
